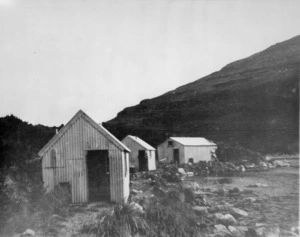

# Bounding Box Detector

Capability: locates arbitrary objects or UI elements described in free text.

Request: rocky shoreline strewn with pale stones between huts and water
[130,161,299,237]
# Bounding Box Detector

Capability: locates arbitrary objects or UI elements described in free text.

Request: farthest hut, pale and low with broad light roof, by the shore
[157,137,217,164]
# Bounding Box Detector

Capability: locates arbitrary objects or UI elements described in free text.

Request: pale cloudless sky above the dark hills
[0,0,300,126]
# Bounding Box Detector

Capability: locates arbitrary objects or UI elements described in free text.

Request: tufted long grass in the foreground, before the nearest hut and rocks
[82,192,200,237]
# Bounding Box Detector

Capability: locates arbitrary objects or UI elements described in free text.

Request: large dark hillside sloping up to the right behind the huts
[104,36,300,153]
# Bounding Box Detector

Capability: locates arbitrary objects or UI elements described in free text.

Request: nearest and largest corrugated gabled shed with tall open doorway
[39,110,130,203]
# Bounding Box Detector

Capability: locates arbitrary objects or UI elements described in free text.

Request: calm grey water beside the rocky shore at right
[190,168,299,229]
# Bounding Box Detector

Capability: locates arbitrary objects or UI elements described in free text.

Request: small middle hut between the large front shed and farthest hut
[122,135,156,171]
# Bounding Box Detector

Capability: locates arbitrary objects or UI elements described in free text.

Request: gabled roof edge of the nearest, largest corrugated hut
[38,110,130,157]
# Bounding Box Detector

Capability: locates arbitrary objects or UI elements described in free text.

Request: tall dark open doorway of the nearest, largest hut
[86,150,110,201]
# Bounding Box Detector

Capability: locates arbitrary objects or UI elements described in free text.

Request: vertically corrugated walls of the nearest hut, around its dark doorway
[42,116,129,203]
